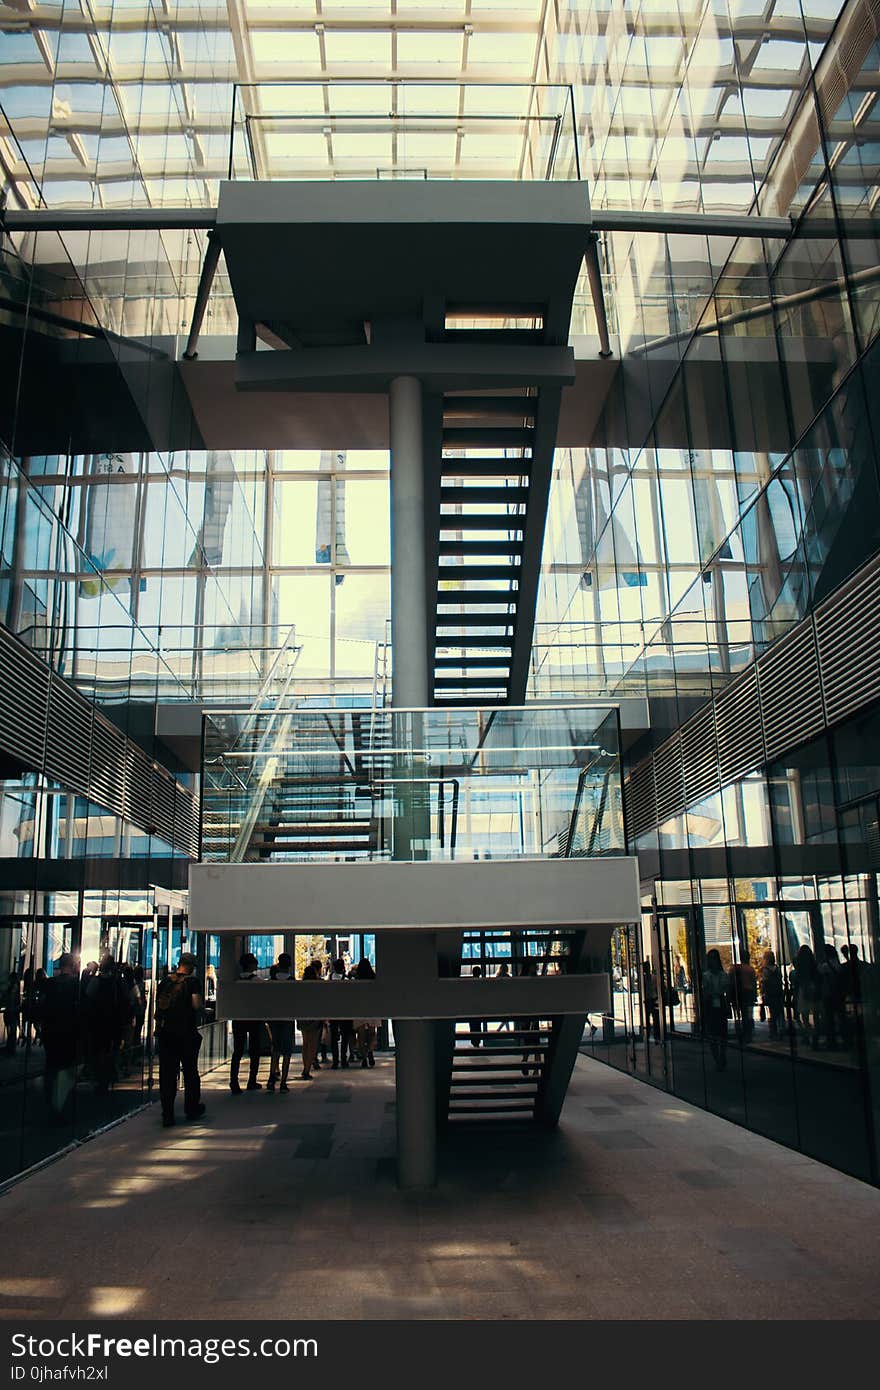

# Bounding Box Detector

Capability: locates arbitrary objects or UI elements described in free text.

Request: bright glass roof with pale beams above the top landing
[0,0,856,211]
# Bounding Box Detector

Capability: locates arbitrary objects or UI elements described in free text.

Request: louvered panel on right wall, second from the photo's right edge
[758,620,824,759]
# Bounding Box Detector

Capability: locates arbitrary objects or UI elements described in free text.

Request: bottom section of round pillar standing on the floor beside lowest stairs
[395,1019,437,1188]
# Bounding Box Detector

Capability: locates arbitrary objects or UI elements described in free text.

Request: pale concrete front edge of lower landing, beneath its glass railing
[189,855,641,933]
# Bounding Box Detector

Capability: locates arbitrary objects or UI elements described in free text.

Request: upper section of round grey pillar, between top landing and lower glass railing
[388,377,428,709]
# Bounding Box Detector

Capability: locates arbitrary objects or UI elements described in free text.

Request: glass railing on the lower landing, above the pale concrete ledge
[202,702,626,863]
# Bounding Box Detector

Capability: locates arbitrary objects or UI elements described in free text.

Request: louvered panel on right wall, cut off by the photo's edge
[816,566,880,724]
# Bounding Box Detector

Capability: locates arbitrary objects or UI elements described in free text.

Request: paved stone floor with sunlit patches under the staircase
[0,1058,880,1319]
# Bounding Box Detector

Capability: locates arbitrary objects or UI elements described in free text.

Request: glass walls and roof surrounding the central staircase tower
[0,0,880,1183]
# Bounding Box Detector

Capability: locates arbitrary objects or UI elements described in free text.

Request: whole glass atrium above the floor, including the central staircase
[0,0,880,1316]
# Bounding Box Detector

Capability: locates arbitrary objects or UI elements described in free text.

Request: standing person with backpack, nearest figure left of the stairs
[156,951,204,1129]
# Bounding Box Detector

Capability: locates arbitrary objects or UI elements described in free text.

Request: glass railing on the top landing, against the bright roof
[228,78,581,181]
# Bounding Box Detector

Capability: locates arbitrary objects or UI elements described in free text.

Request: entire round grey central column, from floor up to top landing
[389,377,437,1188]
